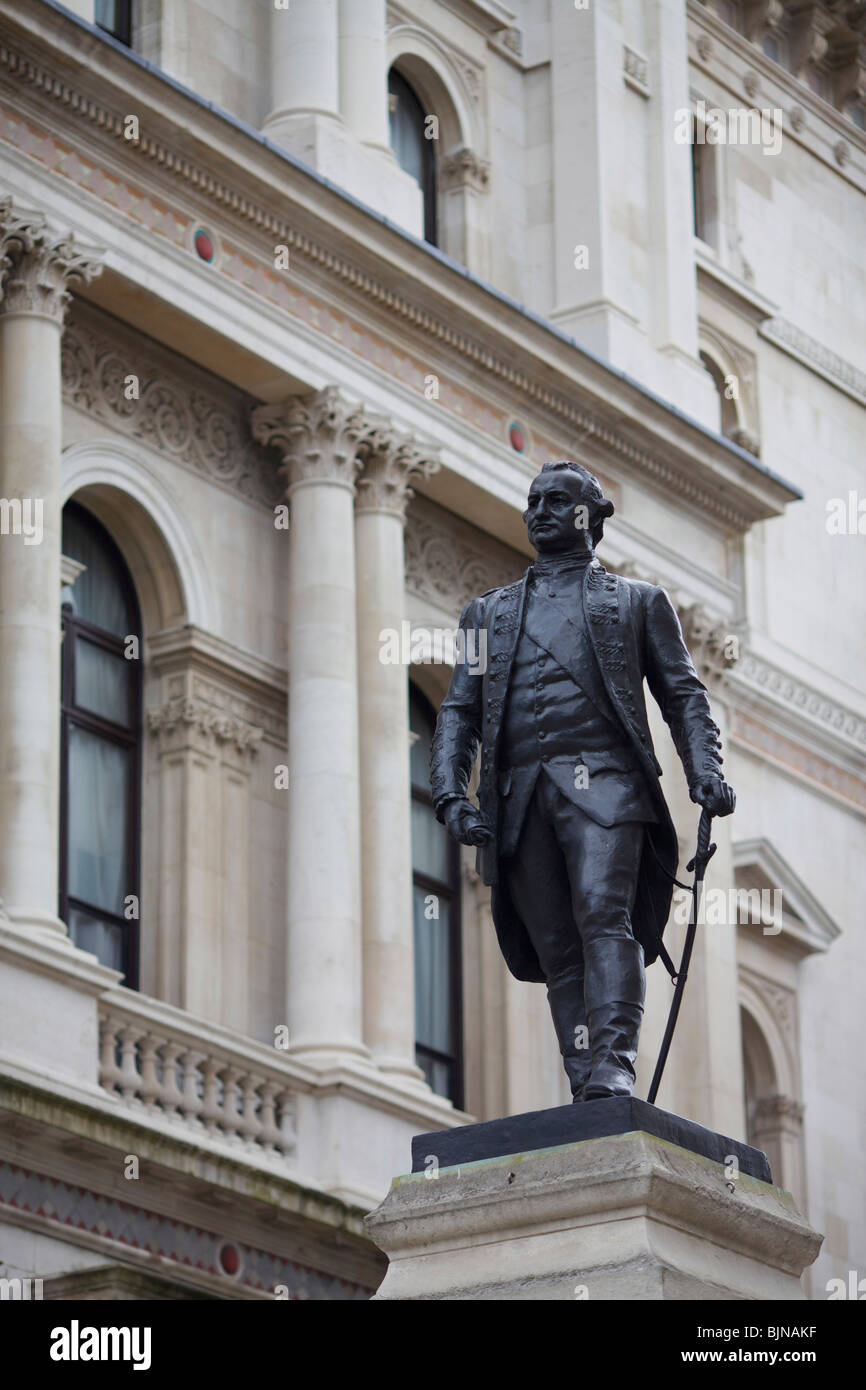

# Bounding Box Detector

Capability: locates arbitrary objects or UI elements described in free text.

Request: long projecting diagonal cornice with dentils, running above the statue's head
[0,0,798,531]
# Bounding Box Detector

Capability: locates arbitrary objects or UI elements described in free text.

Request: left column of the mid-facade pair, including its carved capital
[253,386,367,1062]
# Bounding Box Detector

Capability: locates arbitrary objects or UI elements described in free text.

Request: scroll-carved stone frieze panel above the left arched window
[61,304,279,506]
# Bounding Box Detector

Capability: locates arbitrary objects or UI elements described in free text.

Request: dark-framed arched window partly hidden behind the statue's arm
[409,684,463,1108]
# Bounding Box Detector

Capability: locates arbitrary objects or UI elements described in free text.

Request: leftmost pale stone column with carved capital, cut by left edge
[0,199,99,935]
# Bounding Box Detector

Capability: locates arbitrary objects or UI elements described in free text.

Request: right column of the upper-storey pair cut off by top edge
[339,0,389,149]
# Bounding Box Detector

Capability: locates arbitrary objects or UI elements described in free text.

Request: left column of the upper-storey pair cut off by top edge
[263,0,339,154]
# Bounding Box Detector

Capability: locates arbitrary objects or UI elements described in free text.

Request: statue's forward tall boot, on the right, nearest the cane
[584,937,646,1101]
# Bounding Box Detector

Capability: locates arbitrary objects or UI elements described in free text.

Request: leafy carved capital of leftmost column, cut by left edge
[0,199,101,324]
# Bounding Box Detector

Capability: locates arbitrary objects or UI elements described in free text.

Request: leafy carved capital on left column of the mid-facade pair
[252,386,371,493]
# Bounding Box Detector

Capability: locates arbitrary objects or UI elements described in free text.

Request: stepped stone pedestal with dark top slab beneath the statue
[367,1101,822,1301]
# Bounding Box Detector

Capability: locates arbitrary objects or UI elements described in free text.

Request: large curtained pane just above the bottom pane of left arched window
[67,724,129,915]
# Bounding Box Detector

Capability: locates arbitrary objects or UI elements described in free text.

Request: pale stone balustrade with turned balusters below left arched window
[99,988,297,1161]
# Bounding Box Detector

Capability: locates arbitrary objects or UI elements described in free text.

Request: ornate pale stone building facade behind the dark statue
[0,0,866,1298]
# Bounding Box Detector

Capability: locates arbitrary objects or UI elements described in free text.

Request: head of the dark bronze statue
[523,459,613,555]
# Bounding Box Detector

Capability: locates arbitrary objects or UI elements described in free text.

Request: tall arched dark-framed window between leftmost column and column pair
[60,502,142,988]
